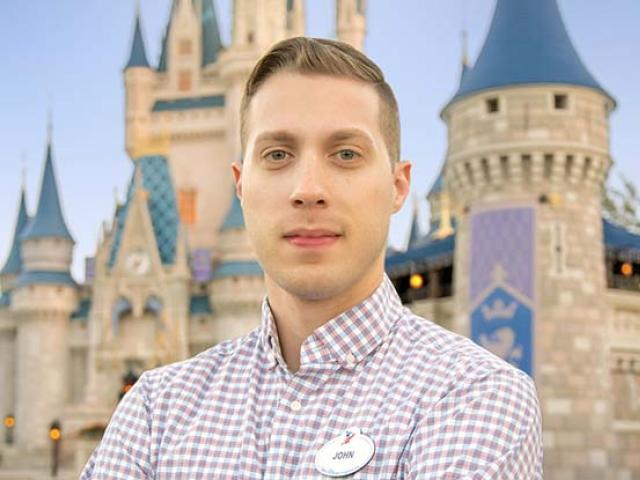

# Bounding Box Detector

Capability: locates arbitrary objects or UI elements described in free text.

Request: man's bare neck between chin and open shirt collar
[265,268,384,373]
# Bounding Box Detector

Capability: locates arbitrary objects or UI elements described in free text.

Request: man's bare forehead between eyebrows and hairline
[247,72,381,143]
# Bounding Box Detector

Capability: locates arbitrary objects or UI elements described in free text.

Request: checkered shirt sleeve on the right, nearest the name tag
[403,368,542,480]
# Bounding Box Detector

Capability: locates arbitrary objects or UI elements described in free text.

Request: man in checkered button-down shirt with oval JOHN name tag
[82,38,542,480]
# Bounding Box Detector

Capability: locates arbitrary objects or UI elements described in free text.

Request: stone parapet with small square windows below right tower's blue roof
[442,85,614,205]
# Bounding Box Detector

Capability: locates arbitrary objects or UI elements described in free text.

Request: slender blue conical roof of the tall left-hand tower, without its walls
[21,142,73,242]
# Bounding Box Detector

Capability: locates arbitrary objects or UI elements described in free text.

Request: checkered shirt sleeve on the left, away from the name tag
[80,374,154,480]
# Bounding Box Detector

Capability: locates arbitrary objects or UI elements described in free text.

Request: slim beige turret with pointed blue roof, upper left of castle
[124,11,155,155]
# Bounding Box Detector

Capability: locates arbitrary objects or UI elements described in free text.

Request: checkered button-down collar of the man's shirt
[260,274,403,368]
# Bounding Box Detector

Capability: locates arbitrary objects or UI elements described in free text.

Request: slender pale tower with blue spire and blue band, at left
[11,141,77,449]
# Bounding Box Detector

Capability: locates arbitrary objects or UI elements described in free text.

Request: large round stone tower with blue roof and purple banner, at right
[442,0,615,479]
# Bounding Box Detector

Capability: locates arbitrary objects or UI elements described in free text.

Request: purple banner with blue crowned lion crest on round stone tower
[470,208,535,377]
